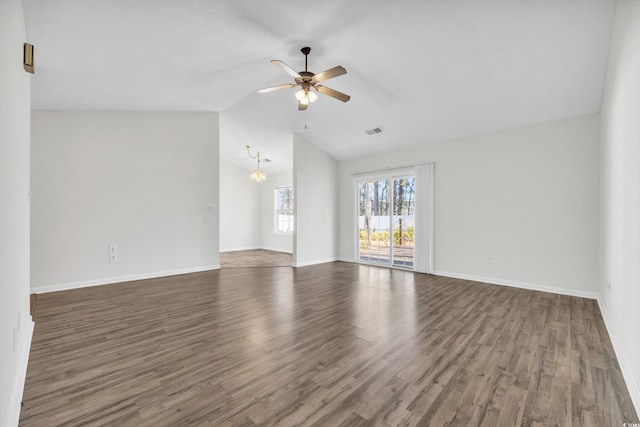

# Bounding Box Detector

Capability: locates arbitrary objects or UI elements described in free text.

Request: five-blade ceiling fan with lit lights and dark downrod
[258,47,351,110]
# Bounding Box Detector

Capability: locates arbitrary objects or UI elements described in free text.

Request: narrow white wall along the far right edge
[598,1,640,412]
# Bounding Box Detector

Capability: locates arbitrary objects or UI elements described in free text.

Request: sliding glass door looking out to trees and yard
[356,174,415,268]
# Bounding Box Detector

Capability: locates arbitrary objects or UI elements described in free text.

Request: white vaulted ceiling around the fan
[24,0,615,172]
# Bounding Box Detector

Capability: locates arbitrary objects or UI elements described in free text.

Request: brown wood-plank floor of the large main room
[20,262,639,427]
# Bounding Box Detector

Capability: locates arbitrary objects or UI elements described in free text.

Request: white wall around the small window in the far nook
[260,171,297,253]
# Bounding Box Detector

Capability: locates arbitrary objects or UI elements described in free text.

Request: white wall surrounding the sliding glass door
[339,115,599,297]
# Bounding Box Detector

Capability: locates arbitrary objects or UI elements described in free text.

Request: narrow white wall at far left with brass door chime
[0,0,33,426]
